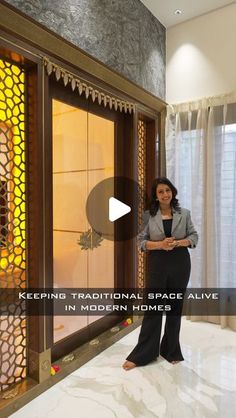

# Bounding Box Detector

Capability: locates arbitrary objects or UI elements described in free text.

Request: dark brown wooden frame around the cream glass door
[45,77,135,361]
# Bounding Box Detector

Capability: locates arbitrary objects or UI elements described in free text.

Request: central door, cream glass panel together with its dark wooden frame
[47,80,133,358]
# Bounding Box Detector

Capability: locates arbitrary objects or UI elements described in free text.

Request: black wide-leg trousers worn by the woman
[126,247,191,366]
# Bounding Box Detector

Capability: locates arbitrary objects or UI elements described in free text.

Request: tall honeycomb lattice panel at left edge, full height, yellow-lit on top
[0,59,26,390]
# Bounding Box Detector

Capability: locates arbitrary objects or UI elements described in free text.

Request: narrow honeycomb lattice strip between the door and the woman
[138,119,147,288]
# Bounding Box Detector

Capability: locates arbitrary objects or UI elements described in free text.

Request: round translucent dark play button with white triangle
[86,176,141,241]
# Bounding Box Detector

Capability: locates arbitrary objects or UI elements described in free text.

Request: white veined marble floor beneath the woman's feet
[11,318,236,418]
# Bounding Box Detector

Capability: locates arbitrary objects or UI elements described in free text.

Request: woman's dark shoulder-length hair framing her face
[149,177,181,216]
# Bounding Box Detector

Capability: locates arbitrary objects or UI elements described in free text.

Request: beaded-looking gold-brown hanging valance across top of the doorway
[43,57,135,113]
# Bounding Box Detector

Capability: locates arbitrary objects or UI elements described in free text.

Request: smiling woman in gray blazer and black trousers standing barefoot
[123,177,198,370]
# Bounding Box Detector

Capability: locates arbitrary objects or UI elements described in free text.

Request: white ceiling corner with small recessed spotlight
[141,0,235,28]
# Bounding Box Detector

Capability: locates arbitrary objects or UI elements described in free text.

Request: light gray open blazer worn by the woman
[138,208,198,251]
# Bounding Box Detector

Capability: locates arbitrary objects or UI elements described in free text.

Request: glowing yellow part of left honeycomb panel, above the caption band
[0,60,25,274]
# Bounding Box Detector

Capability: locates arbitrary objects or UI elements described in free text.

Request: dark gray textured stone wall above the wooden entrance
[3,0,166,99]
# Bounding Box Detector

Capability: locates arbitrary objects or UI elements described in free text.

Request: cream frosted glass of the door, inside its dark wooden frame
[53,100,115,343]
